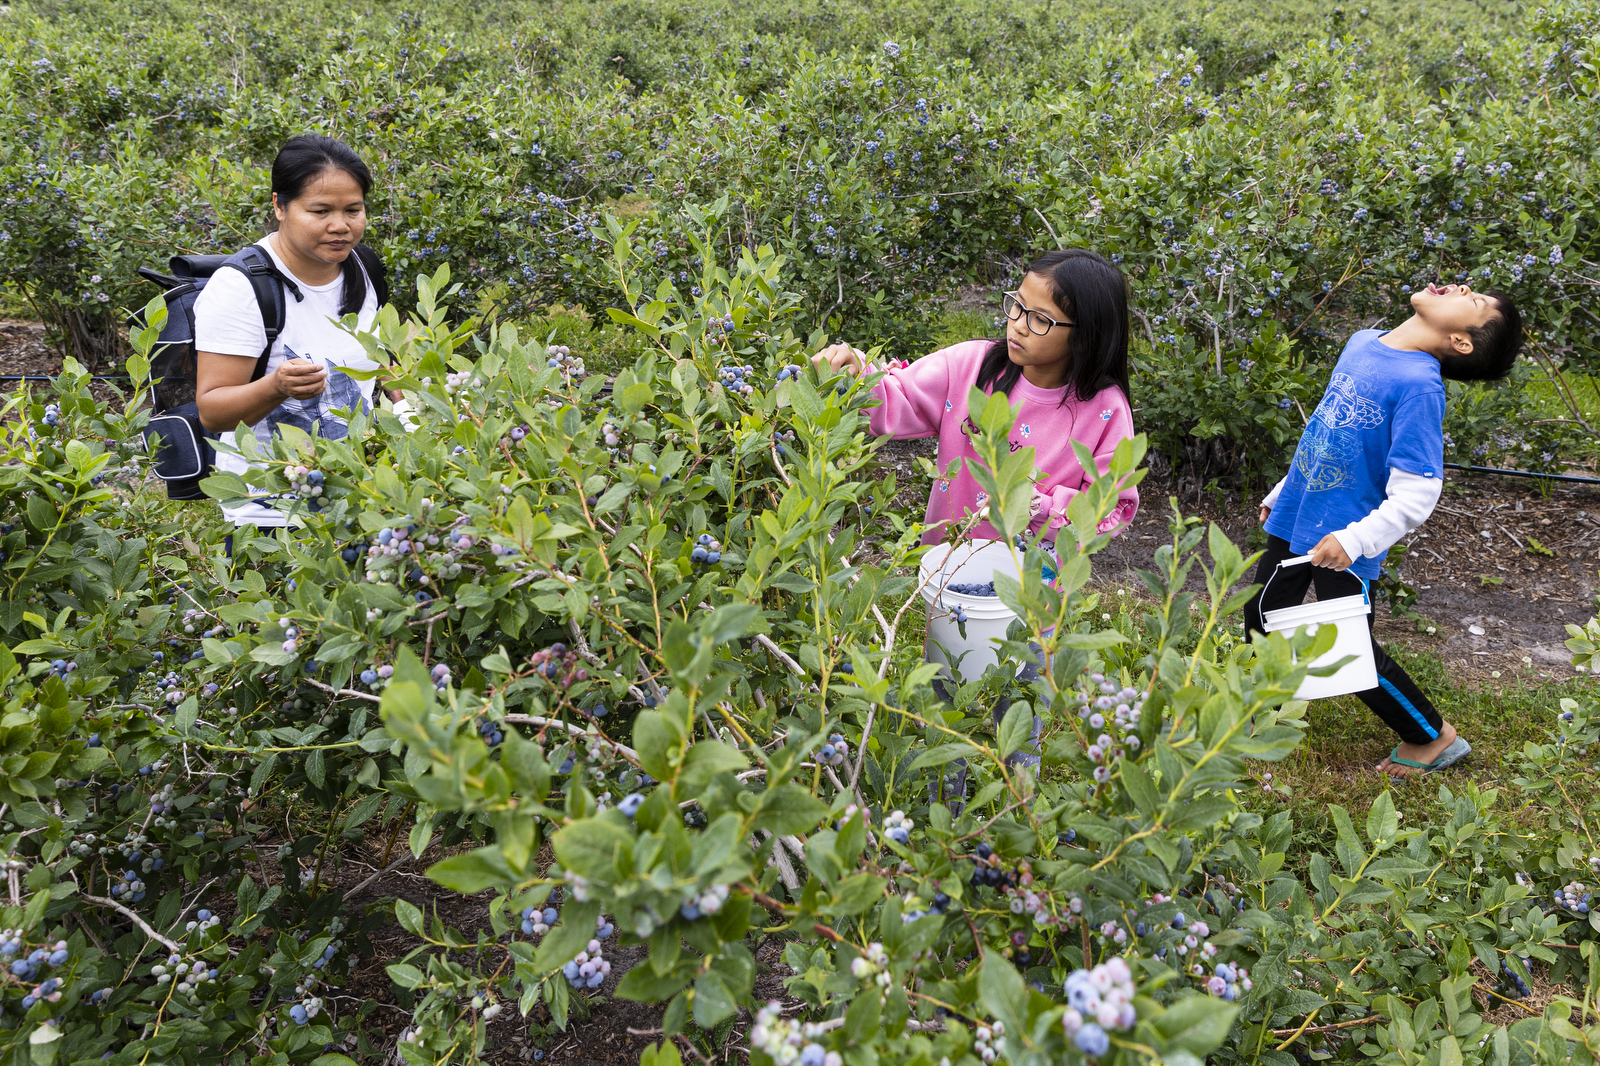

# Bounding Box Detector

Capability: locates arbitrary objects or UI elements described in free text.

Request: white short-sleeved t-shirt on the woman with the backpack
[195,237,378,527]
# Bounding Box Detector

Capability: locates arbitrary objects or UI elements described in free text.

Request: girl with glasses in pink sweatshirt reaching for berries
[813,248,1139,544]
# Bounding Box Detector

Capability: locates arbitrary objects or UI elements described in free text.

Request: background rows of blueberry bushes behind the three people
[0,0,1600,480]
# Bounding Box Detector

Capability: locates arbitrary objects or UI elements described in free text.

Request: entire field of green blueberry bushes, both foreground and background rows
[0,0,1600,1066]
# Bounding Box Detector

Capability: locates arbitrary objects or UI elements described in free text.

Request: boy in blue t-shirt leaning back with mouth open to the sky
[1245,285,1522,776]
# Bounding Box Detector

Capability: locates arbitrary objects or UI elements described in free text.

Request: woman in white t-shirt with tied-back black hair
[194,134,393,528]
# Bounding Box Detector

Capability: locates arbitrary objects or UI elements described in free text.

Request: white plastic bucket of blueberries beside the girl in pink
[918,541,1021,680]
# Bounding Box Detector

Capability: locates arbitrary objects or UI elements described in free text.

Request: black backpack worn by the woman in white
[128,245,389,499]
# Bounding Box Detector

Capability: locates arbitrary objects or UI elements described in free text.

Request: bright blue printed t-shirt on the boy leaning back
[1266,330,1445,581]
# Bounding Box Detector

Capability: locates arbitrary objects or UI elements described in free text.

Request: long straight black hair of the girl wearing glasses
[976,248,1131,403]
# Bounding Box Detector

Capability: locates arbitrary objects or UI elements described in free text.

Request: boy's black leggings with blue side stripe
[1245,536,1445,744]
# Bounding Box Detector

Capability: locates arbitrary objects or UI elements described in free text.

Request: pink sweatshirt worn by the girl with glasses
[870,341,1139,544]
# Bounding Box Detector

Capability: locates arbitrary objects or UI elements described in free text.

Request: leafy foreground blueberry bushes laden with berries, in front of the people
[0,226,1600,1066]
